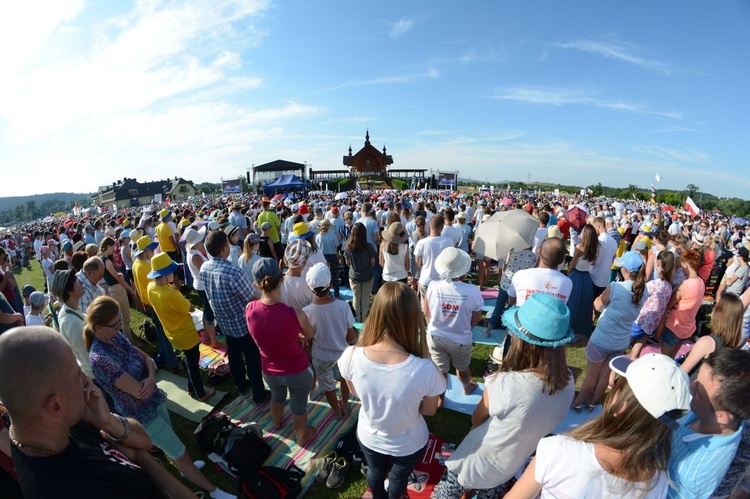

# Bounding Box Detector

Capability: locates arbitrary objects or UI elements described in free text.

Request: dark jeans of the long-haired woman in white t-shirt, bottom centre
[357,439,424,499]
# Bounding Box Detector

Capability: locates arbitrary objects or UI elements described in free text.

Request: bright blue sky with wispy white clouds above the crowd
[0,0,750,199]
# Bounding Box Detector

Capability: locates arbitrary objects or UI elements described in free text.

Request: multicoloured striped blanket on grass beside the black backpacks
[224,393,360,495]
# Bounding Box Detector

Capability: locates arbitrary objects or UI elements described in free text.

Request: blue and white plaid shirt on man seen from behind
[200,257,255,338]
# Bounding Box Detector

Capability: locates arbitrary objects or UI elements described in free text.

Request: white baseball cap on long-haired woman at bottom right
[609,353,691,430]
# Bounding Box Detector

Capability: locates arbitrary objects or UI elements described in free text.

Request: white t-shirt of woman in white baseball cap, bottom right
[534,435,669,499]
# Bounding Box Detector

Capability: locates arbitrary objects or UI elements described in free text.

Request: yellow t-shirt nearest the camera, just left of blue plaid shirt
[148,281,200,350]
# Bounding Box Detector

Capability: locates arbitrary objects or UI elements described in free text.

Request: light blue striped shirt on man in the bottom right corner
[667,412,744,499]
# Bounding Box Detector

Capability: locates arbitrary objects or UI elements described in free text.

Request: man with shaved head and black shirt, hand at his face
[0,326,195,499]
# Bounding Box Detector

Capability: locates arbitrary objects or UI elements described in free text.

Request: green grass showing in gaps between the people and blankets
[8,262,586,498]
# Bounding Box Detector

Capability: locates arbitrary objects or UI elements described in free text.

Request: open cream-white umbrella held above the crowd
[474,210,539,260]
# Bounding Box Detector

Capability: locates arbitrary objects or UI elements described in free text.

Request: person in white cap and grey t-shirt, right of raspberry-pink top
[302,263,354,420]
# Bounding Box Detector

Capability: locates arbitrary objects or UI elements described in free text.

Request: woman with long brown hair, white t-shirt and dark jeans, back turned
[338,284,446,499]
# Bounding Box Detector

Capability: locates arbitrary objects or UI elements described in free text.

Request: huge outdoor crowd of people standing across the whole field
[0,191,750,498]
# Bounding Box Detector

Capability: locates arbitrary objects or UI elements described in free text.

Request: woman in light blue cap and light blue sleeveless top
[571,251,648,412]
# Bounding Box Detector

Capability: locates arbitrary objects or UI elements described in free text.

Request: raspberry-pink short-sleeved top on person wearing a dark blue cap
[245,300,310,376]
